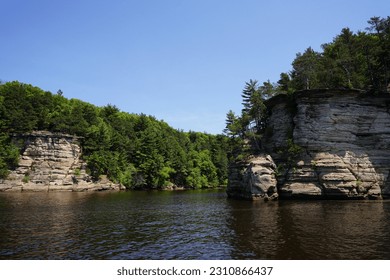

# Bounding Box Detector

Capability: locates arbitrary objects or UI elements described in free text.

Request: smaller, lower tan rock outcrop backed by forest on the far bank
[0,131,121,191]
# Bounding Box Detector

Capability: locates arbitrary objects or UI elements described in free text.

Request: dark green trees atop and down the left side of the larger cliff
[225,17,390,149]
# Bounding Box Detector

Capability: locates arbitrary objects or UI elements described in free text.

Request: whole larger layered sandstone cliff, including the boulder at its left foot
[227,90,390,199]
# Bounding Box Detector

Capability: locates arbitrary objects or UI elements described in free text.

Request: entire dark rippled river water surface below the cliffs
[0,191,390,259]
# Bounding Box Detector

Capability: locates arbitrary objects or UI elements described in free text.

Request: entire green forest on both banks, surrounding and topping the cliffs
[0,17,390,188]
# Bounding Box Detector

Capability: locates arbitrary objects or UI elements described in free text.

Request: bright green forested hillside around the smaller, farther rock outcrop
[0,81,228,189]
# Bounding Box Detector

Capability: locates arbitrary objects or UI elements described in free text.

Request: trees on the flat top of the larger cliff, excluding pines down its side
[284,17,390,93]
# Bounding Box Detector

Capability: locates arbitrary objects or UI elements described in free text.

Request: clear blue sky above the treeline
[0,0,390,134]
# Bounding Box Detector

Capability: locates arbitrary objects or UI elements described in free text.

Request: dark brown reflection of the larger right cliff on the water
[228,201,390,259]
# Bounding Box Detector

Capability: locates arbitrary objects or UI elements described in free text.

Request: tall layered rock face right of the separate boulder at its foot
[279,91,390,198]
